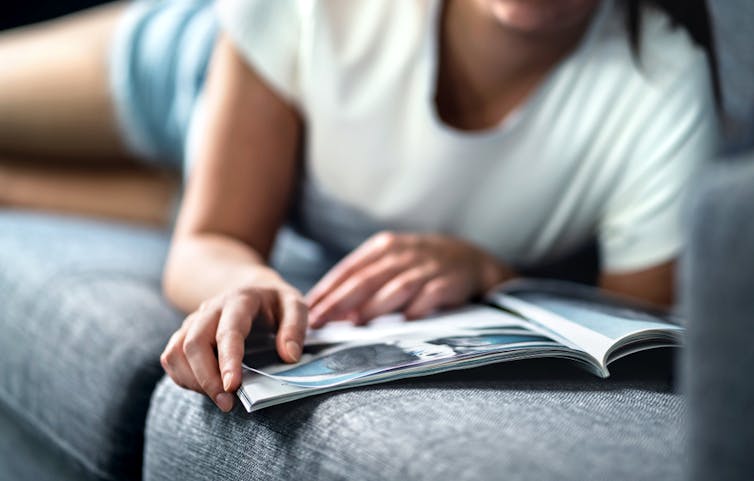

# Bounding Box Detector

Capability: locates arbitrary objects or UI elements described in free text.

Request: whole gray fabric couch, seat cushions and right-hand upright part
[0,155,754,480]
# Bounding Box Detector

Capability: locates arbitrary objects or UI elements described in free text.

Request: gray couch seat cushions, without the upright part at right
[0,212,684,480]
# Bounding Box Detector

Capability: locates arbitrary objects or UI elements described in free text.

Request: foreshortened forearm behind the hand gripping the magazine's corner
[163,233,282,312]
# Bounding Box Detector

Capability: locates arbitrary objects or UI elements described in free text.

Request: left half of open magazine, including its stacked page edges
[239,306,584,409]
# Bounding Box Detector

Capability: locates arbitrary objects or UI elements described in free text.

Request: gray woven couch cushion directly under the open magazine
[144,352,685,481]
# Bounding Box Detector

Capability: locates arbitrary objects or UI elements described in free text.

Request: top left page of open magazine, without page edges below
[244,306,557,387]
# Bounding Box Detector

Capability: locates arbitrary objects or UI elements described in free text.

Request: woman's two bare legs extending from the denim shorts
[0,2,177,223]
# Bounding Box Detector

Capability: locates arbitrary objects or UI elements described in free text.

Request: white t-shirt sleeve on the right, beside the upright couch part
[599,52,717,273]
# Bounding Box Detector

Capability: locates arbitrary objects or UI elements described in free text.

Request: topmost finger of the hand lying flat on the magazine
[306,232,400,307]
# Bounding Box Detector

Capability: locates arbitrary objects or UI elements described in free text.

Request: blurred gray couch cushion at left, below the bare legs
[0,211,180,479]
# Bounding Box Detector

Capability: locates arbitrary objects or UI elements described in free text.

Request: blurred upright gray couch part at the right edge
[683,155,754,481]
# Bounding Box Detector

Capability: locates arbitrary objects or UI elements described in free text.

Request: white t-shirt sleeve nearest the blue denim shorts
[215,0,303,105]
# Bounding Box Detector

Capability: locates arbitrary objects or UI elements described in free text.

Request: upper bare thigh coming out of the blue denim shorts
[0,3,134,162]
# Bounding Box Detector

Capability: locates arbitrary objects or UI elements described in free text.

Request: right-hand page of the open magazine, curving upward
[494,280,683,363]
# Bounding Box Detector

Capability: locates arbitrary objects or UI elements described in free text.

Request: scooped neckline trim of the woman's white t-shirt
[423,0,612,140]
